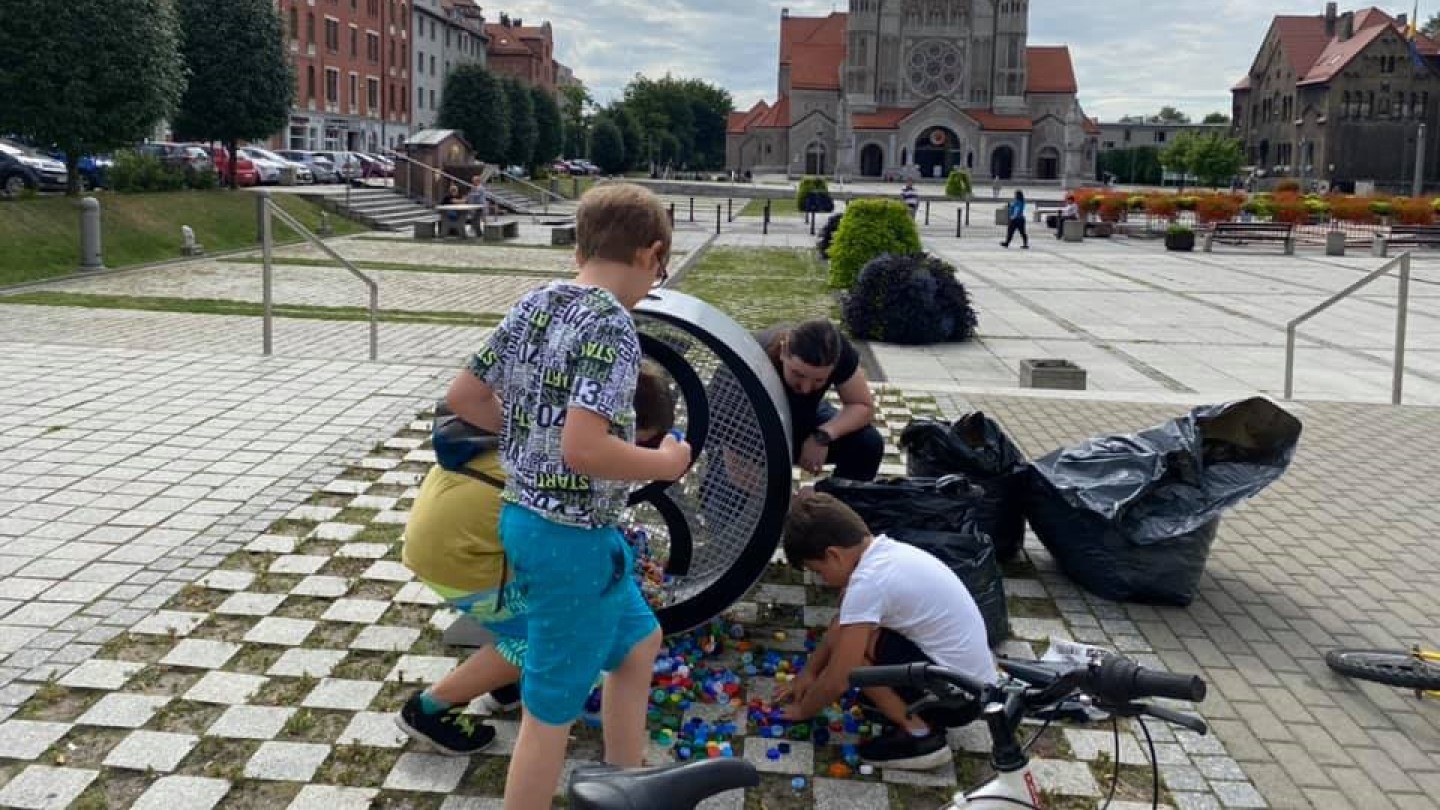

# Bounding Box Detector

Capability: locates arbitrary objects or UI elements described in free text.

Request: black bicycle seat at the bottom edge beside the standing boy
[570,758,760,810]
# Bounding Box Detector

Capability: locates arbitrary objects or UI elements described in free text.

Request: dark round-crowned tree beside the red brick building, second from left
[173,0,295,187]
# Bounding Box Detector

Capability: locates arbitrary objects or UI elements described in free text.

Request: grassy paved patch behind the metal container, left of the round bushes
[678,248,841,329]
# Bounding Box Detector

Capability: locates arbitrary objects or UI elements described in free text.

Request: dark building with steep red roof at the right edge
[1231,3,1440,190]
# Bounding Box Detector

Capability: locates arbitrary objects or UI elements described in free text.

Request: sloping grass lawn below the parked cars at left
[0,190,366,285]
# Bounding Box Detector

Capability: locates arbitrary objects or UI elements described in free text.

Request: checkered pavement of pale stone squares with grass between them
[0,386,1238,810]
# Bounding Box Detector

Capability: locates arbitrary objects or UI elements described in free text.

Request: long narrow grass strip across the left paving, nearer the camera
[0,291,501,326]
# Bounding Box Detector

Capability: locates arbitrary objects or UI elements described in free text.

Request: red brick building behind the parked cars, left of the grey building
[272,0,412,151]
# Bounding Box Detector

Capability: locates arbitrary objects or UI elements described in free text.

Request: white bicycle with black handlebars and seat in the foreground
[569,654,1208,810]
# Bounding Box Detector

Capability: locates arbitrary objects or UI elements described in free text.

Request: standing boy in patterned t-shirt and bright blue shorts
[448,184,690,810]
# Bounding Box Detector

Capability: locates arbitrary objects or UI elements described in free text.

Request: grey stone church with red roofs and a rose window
[726,0,1100,187]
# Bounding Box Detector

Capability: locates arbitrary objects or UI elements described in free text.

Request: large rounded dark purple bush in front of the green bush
[844,252,978,346]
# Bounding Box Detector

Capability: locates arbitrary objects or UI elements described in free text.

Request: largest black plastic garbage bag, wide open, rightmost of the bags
[1025,398,1302,607]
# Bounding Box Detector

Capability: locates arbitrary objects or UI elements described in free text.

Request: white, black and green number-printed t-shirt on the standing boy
[469,281,641,528]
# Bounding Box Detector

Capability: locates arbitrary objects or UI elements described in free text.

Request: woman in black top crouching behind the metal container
[756,320,886,481]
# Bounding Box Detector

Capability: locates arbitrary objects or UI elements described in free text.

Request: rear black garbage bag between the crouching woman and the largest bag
[900,411,1025,561]
